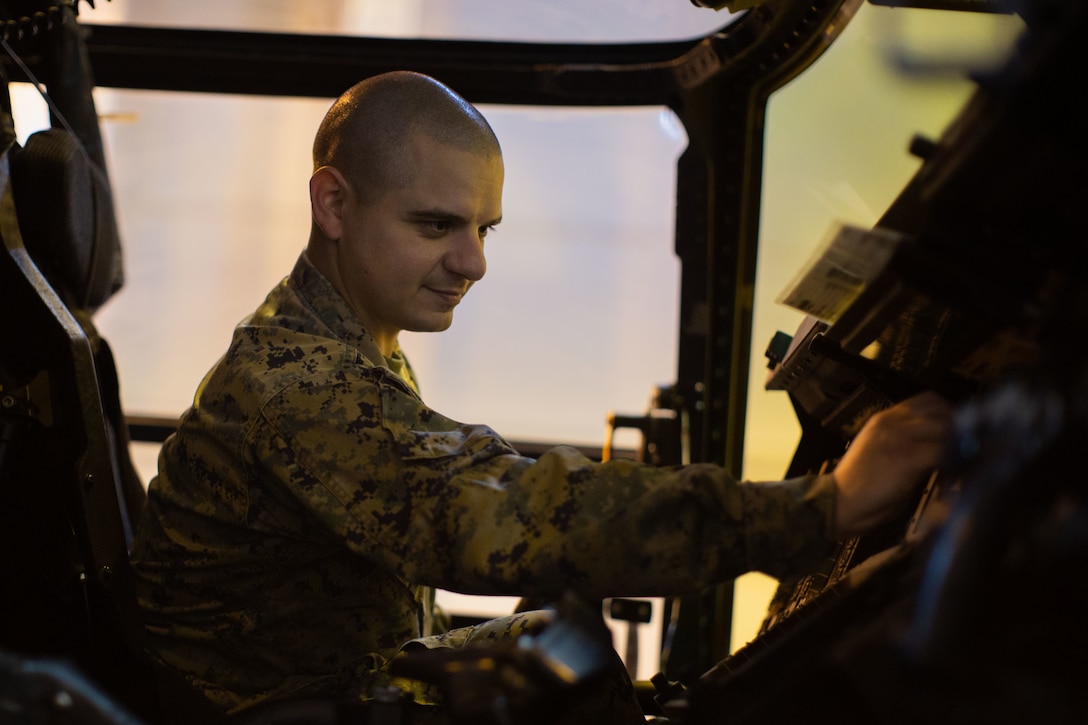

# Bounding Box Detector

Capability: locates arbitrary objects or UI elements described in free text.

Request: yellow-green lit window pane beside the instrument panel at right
[732,3,1022,649]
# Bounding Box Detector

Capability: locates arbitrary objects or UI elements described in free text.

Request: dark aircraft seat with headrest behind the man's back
[0,106,222,723]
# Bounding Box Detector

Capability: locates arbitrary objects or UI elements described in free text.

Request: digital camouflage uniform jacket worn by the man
[133,255,833,710]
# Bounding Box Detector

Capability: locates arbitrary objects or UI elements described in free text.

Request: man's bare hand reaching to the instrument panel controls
[833,392,952,537]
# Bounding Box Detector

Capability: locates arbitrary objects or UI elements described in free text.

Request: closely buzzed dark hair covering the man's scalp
[313,71,502,200]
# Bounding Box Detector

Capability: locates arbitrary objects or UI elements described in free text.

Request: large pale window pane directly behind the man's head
[78,89,684,445]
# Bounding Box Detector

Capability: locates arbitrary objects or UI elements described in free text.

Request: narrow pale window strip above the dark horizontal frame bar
[81,0,734,42]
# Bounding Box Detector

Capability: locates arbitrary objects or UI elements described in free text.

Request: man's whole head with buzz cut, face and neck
[306,71,505,357]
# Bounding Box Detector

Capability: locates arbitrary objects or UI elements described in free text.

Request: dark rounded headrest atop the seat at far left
[11,128,124,311]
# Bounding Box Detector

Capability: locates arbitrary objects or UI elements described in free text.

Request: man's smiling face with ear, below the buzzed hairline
[337,134,503,355]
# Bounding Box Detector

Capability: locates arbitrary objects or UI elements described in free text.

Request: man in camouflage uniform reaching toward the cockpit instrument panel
[133,72,949,722]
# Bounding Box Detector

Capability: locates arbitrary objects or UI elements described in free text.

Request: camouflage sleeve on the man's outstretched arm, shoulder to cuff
[250,370,833,598]
